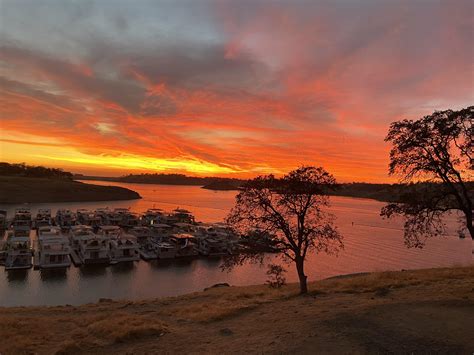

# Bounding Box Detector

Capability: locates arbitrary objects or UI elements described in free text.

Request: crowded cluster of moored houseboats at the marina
[0,207,238,270]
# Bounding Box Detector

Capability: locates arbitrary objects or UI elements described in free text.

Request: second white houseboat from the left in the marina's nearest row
[35,227,71,269]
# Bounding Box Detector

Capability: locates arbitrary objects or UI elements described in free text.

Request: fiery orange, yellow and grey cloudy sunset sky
[0,0,474,182]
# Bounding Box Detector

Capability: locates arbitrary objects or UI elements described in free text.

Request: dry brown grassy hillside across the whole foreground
[0,267,474,354]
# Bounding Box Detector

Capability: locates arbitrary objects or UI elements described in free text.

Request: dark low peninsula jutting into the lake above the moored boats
[0,176,140,203]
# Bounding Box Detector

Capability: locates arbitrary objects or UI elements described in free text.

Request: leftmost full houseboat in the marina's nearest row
[5,230,33,270]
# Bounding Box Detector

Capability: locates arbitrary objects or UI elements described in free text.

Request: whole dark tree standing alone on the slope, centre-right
[226,166,343,293]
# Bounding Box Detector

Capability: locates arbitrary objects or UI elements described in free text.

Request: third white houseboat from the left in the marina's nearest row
[70,225,110,264]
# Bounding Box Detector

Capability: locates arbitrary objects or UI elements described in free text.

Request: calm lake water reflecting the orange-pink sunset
[0,181,472,306]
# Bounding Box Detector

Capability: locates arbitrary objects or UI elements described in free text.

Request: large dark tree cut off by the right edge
[381,106,474,247]
